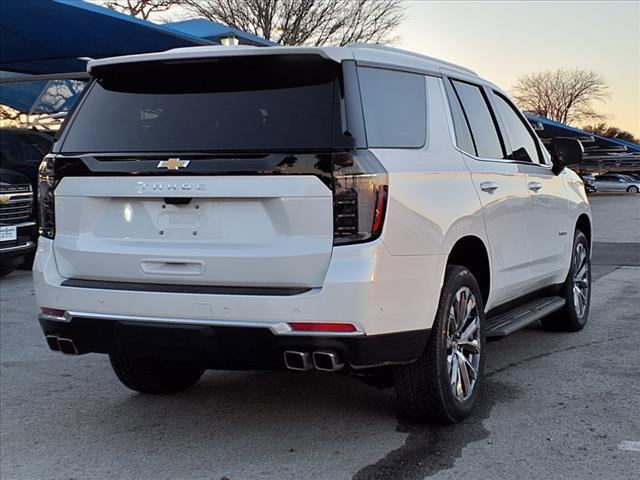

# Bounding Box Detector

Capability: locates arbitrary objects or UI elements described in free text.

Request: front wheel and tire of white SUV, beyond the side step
[542,230,591,332]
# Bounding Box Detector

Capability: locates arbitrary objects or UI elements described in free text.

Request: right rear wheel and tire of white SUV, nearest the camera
[394,265,485,423]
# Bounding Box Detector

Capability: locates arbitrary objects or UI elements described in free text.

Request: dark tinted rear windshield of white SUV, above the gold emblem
[62,56,338,152]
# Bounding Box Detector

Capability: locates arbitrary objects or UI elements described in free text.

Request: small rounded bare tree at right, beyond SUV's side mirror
[512,68,609,123]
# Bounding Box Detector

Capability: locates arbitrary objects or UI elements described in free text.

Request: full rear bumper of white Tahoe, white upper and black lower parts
[33,238,446,368]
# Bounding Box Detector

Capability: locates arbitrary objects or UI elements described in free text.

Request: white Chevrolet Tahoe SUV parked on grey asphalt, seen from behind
[34,45,591,422]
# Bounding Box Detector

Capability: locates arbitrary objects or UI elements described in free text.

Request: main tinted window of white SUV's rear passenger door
[453,80,504,158]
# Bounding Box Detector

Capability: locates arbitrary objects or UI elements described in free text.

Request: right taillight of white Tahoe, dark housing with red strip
[333,150,389,245]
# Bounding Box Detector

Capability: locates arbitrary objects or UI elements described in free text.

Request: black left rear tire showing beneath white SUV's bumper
[109,353,204,394]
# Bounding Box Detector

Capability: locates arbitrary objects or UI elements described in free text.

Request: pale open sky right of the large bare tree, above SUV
[398,0,640,137]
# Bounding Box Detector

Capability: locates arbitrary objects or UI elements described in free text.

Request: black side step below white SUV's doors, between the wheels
[486,297,565,340]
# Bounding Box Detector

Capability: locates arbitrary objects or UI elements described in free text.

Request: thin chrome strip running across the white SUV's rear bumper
[64,311,364,337]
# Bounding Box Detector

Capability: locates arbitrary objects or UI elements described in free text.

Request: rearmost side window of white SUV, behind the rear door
[358,68,427,148]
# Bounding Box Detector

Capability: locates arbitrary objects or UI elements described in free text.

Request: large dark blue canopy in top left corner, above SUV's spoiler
[0,0,212,74]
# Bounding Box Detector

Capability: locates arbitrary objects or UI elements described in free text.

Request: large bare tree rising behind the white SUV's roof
[181,0,404,45]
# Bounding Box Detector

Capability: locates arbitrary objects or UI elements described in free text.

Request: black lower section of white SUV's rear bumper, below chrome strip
[39,315,429,370]
